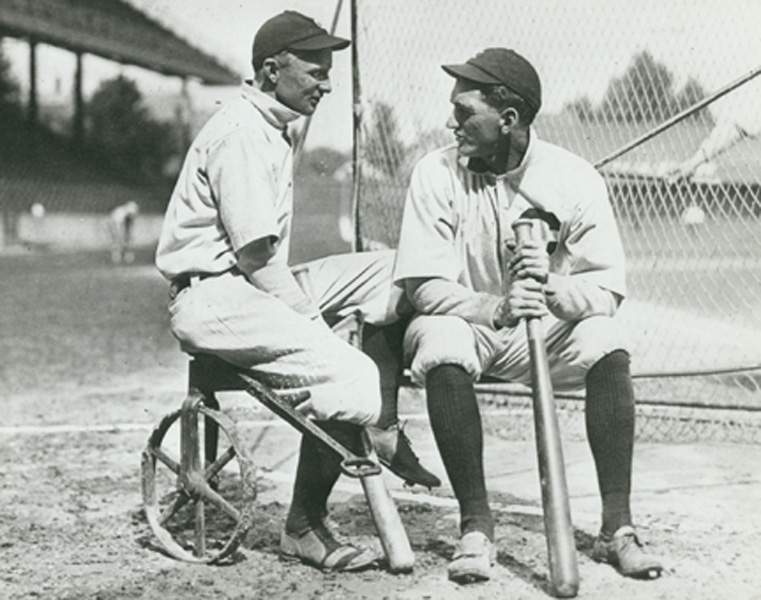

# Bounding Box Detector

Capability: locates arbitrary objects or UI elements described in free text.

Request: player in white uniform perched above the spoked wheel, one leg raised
[156,11,439,571]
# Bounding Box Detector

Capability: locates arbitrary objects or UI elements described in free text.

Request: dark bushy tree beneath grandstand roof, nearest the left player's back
[88,75,177,179]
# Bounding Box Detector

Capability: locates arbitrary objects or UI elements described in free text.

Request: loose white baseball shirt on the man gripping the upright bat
[394,130,626,296]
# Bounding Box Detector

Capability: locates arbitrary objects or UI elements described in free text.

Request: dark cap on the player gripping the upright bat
[441,48,542,111]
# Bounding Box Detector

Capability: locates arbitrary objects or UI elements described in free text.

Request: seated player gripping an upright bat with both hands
[394,48,662,582]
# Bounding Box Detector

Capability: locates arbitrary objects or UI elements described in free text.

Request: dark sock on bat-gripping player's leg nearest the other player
[426,364,494,540]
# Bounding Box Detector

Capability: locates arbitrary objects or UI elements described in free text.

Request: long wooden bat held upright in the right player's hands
[513,219,579,598]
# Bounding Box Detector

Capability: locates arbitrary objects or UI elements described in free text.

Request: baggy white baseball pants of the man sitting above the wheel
[169,251,403,425]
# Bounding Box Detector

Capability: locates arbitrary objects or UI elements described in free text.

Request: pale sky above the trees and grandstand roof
[5,0,761,150]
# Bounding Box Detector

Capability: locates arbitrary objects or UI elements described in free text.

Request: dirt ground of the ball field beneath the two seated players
[0,251,761,600]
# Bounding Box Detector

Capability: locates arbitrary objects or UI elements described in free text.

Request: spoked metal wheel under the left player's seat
[142,396,256,563]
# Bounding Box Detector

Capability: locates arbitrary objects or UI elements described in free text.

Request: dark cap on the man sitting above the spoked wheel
[252,10,351,65]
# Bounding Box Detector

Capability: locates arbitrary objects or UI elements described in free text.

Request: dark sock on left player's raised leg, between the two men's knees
[362,320,407,429]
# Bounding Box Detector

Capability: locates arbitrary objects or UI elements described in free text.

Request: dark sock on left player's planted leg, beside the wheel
[285,421,364,535]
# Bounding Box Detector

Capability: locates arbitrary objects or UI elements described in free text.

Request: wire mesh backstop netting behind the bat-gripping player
[353,0,761,440]
